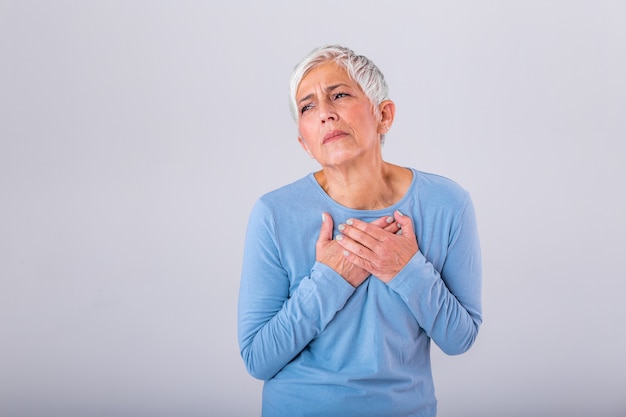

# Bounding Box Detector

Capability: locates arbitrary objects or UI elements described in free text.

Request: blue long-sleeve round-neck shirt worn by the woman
[238,170,482,417]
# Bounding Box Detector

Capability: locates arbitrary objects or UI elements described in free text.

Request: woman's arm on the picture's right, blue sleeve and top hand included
[340,195,482,355]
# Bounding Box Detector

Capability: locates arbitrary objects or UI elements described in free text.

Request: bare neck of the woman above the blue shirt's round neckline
[315,161,411,210]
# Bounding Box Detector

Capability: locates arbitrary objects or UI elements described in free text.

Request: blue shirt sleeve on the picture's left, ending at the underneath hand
[238,200,354,380]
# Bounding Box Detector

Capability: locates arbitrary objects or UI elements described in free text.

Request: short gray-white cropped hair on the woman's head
[289,45,389,121]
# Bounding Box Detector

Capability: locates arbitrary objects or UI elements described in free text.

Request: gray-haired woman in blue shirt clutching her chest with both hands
[238,46,481,417]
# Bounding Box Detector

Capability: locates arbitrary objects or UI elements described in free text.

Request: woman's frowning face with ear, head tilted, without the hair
[296,63,385,167]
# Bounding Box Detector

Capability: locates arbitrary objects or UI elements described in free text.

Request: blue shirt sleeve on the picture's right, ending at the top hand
[389,195,482,355]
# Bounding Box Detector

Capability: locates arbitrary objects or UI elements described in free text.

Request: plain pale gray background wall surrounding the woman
[0,0,626,417]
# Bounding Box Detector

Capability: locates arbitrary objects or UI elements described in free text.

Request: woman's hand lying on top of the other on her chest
[336,211,419,283]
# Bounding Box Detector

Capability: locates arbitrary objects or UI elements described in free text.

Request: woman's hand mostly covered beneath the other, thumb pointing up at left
[315,213,400,288]
